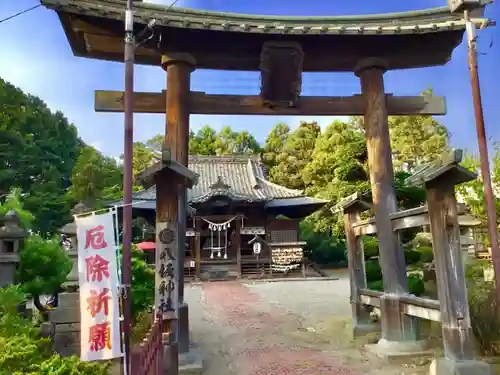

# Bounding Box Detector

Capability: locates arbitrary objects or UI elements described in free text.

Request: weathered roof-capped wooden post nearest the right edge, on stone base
[409,150,492,375]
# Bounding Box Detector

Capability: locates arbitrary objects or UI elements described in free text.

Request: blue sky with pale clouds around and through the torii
[0,0,500,156]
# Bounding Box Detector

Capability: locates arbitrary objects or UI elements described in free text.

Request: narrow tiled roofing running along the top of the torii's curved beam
[42,0,486,35]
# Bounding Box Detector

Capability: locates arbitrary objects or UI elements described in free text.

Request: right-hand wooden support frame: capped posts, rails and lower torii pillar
[332,150,492,375]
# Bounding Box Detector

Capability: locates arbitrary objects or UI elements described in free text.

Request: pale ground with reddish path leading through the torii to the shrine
[186,275,428,375]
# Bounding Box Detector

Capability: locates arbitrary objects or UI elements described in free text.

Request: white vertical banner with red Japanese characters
[75,212,123,361]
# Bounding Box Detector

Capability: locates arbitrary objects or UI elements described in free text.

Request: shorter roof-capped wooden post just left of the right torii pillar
[332,193,379,337]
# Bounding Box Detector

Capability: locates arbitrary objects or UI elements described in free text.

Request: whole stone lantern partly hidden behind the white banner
[49,203,88,356]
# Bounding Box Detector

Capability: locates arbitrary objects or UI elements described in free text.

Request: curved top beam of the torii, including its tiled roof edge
[41,0,492,71]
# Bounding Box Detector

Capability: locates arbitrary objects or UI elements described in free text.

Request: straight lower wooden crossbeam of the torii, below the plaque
[95,90,446,116]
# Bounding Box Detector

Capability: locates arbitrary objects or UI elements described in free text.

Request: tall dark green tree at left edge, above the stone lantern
[0,79,83,234]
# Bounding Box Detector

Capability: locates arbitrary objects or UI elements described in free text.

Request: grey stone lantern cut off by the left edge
[0,210,28,288]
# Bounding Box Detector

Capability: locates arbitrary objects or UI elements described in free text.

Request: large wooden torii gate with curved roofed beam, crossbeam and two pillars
[42,0,494,374]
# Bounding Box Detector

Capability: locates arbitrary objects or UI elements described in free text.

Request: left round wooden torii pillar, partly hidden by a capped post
[162,53,196,353]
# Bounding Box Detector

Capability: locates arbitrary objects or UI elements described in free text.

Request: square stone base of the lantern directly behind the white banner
[49,293,80,357]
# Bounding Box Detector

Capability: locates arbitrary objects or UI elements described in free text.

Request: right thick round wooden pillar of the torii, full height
[356,59,423,352]
